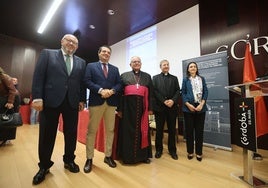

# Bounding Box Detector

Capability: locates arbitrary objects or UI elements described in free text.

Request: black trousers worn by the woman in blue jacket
[183,112,206,155]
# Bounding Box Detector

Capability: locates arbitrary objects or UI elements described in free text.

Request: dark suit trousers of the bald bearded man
[38,97,78,169]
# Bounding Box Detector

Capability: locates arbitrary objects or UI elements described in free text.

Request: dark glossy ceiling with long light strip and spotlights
[0,0,198,61]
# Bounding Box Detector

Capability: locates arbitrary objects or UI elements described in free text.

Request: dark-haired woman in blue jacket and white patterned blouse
[182,62,208,161]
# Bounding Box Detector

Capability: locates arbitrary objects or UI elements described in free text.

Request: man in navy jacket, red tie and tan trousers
[84,46,121,173]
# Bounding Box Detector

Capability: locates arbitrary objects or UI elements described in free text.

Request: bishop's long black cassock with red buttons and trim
[117,71,153,164]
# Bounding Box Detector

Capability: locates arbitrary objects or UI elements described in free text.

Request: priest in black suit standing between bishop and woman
[153,60,180,160]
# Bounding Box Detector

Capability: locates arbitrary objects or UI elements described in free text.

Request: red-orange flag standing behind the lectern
[243,43,268,137]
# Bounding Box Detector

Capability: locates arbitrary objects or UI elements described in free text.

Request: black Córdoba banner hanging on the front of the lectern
[234,98,257,152]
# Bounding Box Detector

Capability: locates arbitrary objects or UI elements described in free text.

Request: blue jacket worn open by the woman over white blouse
[181,76,208,113]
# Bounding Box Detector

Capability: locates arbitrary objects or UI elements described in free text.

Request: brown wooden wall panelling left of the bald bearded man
[0,35,44,99]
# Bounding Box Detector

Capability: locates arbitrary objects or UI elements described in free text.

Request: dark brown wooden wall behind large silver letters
[199,0,268,84]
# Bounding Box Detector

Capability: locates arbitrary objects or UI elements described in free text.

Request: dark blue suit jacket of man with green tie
[32,49,86,109]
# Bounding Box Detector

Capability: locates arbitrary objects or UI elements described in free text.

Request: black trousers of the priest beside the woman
[154,107,178,153]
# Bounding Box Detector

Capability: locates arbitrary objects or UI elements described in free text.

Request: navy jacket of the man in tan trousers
[84,62,122,106]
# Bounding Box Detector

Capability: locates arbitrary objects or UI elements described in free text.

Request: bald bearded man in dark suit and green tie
[32,34,86,185]
